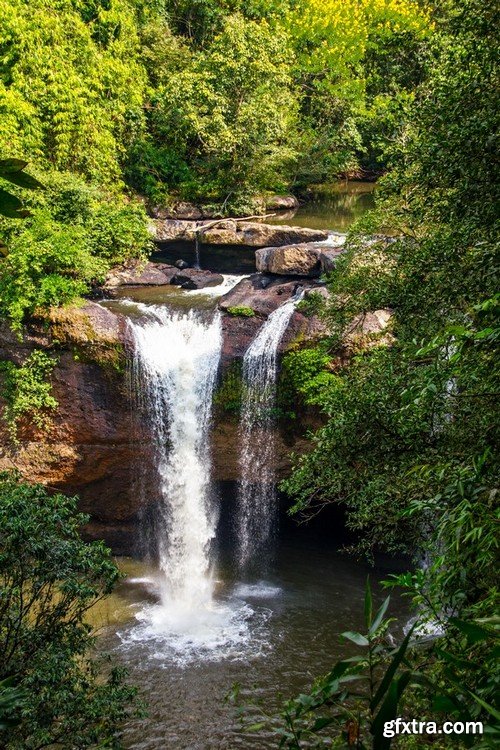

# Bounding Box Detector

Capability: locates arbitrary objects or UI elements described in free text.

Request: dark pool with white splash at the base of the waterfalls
[95,508,405,750]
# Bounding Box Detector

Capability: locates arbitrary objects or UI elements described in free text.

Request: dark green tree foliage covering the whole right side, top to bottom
[276,0,500,747]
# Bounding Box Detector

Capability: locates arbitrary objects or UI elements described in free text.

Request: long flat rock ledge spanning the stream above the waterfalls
[153,219,328,247]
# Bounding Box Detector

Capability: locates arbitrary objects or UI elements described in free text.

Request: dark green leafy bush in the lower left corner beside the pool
[0,474,135,750]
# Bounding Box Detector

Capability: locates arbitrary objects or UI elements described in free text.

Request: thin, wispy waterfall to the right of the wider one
[236,296,300,568]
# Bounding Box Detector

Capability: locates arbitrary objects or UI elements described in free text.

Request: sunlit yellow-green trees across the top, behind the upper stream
[0,0,430,213]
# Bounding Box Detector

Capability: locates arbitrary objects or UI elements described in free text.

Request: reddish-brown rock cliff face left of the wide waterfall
[0,303,149,552]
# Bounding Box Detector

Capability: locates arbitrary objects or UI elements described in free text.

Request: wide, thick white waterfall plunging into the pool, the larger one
[130,307,222,620]
